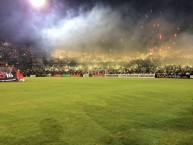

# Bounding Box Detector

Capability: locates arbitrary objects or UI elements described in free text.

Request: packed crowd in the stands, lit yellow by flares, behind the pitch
[0,41,193,77]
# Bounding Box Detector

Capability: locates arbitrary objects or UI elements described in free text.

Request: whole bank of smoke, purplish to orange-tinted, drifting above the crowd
[0,0,192,59]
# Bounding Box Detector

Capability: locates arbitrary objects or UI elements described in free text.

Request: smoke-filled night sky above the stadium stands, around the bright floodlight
[0,0,193,55]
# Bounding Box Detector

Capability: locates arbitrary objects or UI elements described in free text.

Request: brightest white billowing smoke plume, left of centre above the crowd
[42,6,123,50]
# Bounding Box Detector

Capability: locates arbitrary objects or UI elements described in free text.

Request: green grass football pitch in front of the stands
[0,78,193,145]
